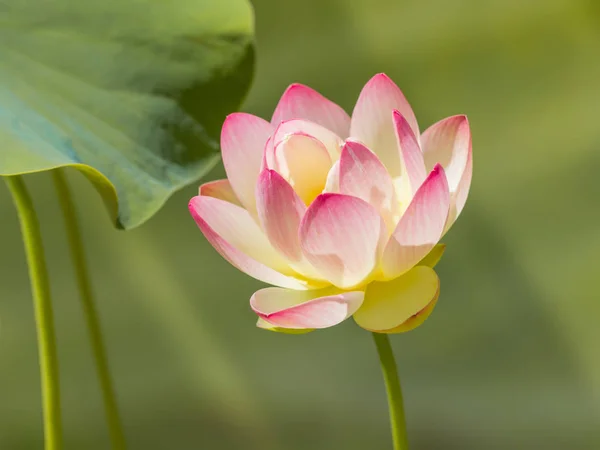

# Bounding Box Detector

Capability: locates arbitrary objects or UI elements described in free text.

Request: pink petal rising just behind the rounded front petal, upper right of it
[339,141,397,224]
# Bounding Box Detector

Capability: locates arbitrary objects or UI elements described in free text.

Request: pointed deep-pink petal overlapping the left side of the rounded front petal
[256,169,306,261]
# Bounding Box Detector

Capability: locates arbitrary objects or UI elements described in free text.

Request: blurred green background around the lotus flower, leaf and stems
[0,0,600,450]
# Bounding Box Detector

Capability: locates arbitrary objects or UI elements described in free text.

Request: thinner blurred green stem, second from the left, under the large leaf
[52,169,126,450]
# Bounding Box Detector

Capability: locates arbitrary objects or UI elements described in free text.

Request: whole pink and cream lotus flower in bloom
[189,74,472,333]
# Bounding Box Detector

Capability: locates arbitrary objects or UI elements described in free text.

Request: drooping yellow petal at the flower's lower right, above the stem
[354,266,440,333]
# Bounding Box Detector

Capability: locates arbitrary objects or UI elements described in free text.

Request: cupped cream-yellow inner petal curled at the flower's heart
[273,134,331,204]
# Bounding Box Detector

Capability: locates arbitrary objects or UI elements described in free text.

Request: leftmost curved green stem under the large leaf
[4,175,62,450]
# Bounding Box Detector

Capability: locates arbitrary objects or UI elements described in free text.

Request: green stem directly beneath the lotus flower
[373,333,408,450]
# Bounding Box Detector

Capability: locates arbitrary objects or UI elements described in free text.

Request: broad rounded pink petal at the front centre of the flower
[300,193,386,289]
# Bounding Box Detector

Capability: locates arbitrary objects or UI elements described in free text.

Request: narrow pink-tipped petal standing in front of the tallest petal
[393,111,427,194]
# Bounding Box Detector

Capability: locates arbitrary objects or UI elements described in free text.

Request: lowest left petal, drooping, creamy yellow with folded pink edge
[250,288,364,330]
